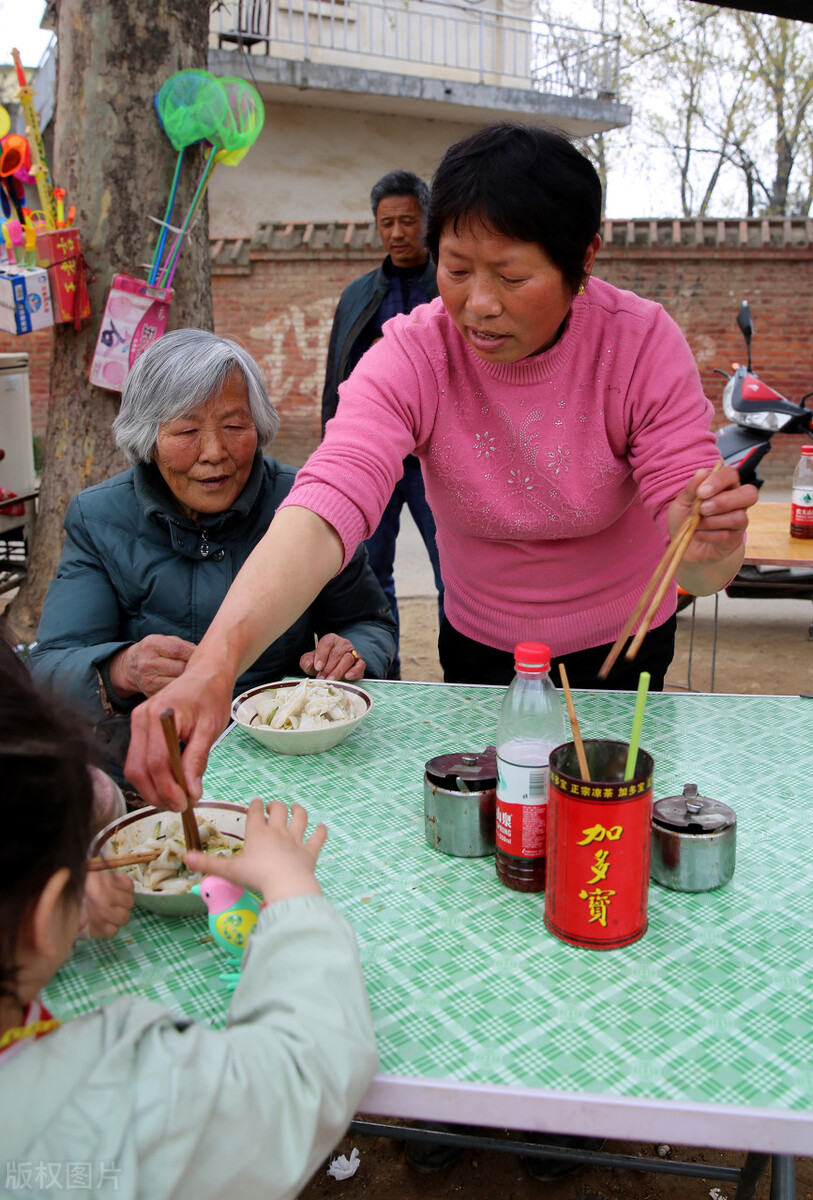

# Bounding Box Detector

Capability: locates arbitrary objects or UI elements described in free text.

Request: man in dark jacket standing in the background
[321,170,444,679]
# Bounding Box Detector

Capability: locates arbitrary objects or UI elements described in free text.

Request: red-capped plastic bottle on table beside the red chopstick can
[495,642,565,892]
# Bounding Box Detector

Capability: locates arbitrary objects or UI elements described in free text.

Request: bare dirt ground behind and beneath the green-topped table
[300,595,813,1200]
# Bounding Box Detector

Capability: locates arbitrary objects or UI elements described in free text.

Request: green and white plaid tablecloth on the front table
[47,683,813,1153]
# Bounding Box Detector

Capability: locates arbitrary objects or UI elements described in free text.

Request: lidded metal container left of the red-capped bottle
[423,746,496,858]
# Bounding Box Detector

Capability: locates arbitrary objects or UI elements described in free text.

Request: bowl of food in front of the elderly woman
[231,679,373,754]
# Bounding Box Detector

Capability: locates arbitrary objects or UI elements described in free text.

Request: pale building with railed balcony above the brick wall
[36,0,631,239]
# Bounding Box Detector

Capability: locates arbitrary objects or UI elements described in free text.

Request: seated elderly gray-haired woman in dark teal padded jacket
[30,329,395,778]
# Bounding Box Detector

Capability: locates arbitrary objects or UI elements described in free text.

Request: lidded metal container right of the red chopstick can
[650,784,736,892]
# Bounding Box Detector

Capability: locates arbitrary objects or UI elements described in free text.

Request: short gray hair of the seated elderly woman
[113,329,279,463]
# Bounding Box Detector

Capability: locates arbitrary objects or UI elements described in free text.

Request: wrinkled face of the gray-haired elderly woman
[152,371,257,520]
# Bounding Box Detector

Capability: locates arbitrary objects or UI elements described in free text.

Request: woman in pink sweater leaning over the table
[127,125,757,808]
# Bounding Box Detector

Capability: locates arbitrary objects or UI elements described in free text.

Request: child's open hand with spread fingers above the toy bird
[186,799,327,904]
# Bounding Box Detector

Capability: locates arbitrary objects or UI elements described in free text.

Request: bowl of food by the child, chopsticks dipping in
[90,800,248,917]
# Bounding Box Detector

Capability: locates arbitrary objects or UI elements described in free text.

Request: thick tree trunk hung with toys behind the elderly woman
[8,0,212,637]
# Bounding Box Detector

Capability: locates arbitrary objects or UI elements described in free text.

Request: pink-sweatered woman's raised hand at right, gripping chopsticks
[667,467,759,596]
